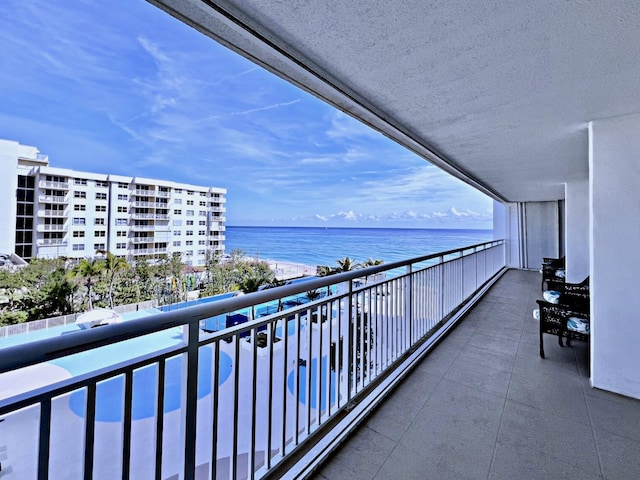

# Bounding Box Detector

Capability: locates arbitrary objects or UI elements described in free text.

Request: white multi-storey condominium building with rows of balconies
[0,140,227,266]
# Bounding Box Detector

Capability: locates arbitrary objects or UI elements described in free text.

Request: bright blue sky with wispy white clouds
[0,0,492,228]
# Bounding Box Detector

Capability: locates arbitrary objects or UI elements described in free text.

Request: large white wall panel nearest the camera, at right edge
[589,111,640,398]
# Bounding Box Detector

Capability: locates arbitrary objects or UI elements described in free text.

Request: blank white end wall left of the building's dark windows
[0,140,19,253]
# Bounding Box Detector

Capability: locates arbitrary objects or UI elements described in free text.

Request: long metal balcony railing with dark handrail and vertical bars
[0,240,504,480]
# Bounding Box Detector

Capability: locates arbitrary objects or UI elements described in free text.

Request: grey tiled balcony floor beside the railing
[314,270,640,480]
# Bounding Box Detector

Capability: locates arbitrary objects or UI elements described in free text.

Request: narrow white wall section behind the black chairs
[565,180,589,283]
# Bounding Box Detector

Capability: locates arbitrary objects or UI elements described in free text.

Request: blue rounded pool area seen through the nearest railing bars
[67,347,232,422]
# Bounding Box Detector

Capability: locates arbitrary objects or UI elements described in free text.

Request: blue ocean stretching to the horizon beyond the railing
[225,226,493,266]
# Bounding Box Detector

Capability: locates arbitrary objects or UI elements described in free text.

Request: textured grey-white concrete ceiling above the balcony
[150,0,640,201]
